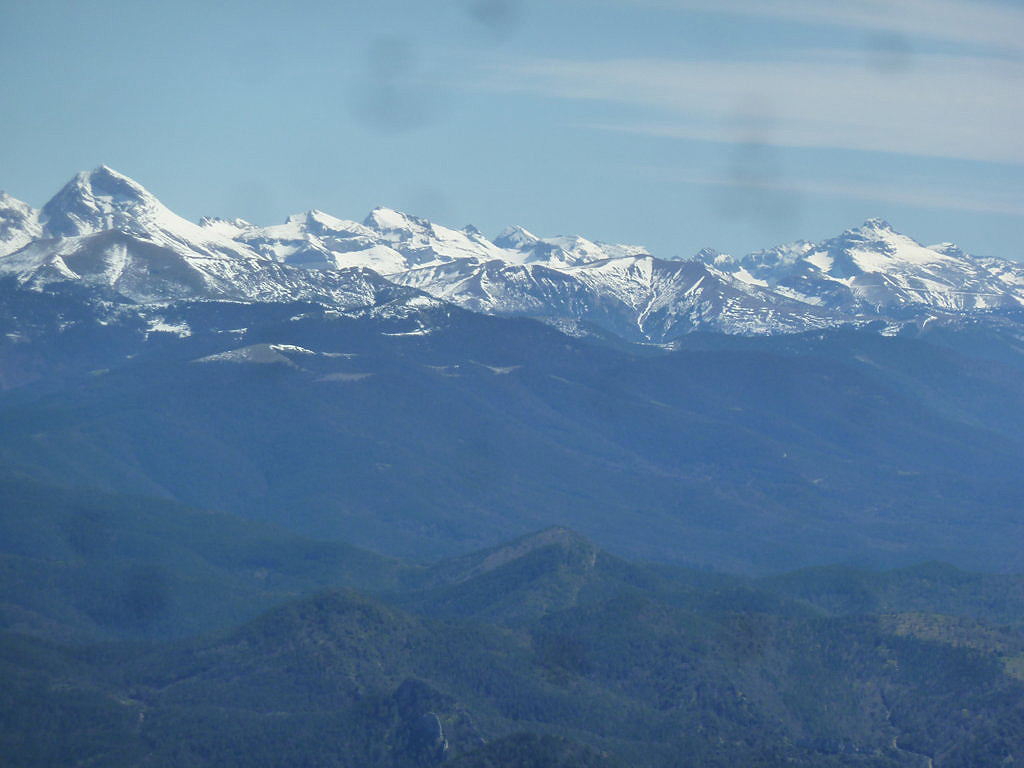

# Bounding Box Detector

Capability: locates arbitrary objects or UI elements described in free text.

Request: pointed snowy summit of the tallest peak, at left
[42,165,170,238]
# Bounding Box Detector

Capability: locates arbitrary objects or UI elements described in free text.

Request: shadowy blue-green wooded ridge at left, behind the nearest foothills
[0,477,419,642]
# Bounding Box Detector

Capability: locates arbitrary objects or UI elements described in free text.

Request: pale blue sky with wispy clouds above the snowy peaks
[0,0,1024,259]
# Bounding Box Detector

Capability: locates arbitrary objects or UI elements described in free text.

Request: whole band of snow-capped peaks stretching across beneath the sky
[0,166,1024,342]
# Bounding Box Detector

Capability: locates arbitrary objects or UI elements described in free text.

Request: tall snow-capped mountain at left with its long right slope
[0,166,421,307]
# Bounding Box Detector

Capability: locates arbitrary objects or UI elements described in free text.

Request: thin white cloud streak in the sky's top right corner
[588,0,1024,54]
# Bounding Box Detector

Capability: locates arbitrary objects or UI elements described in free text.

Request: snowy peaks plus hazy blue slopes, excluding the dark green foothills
[0,167,1024,572]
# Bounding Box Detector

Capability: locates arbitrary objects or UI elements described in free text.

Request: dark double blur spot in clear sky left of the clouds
[352,37,436,133]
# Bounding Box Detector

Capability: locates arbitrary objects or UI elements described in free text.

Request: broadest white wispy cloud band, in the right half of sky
[479,51,1024,164]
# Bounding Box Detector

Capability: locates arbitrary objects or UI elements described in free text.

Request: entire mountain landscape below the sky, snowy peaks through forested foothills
[0,167,1024,768]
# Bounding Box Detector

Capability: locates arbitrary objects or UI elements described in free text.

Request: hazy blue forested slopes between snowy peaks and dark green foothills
[0,282,1024,570]
